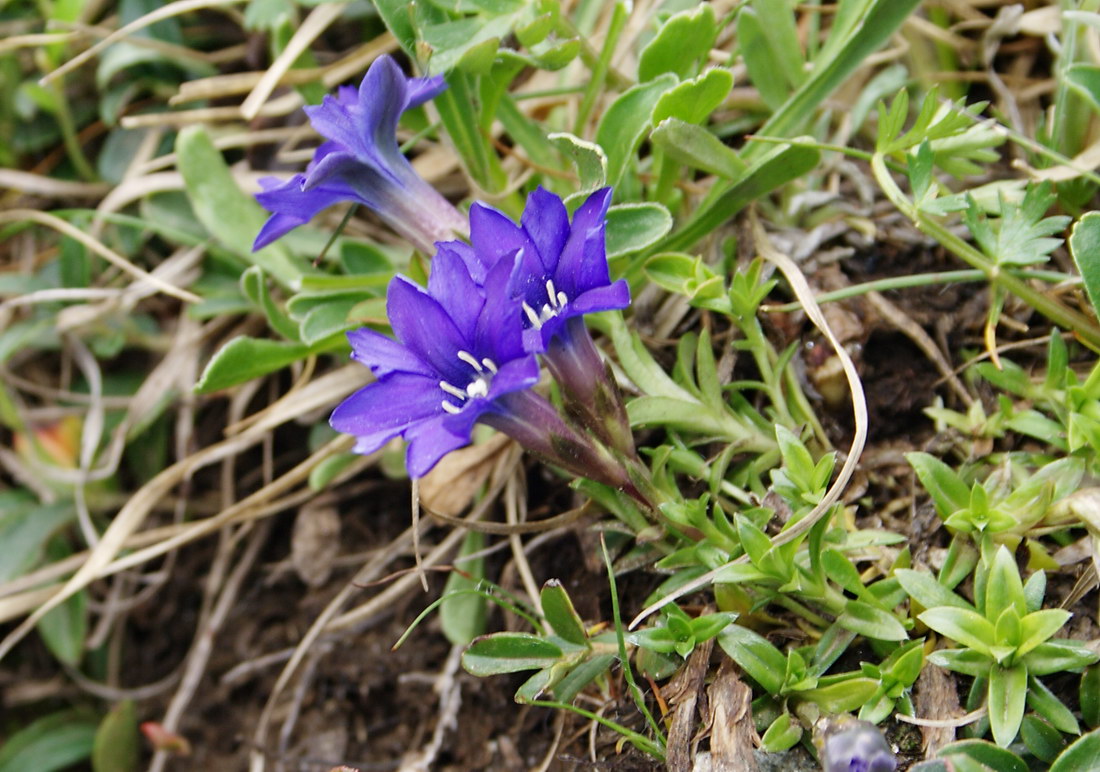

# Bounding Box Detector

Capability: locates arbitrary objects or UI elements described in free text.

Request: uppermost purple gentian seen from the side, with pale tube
[252,56,466,254]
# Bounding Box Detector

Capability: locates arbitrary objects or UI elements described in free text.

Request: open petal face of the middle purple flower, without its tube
[461,188,630,352]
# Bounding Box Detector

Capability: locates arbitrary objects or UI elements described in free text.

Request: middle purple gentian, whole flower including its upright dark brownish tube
[450,187,634,455]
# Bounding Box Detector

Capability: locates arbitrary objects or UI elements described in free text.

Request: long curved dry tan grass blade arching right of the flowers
[629,210,869,630]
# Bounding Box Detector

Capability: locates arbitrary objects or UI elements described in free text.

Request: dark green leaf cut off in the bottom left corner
[0,710,97,772]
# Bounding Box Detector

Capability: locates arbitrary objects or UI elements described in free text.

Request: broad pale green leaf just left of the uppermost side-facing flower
[176,126,305,289]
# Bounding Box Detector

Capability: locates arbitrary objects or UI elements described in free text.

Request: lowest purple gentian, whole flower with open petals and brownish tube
[330,244,633,490]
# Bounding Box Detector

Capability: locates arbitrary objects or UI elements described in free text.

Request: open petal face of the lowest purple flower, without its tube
[331,250,539,477]
